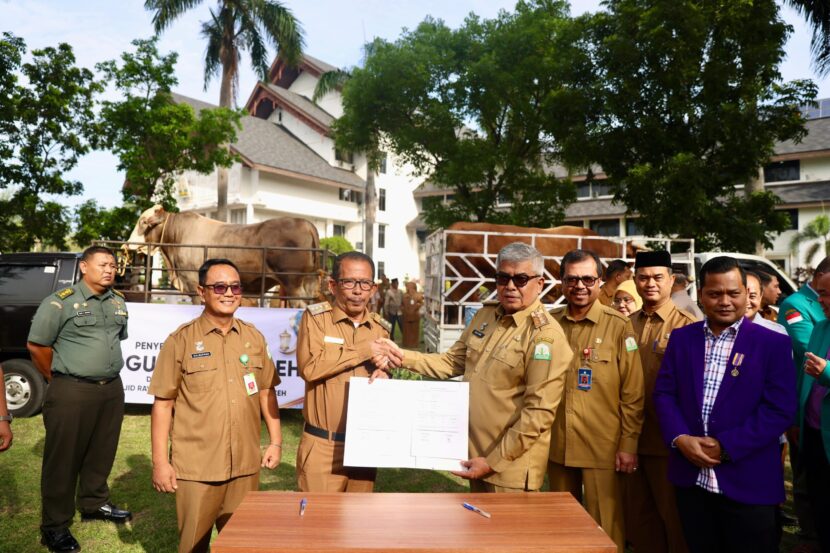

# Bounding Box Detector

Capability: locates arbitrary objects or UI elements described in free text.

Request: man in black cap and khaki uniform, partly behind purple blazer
[624,251,697,553]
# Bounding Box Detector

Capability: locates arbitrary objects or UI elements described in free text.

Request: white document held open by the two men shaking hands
[343,377,470,470]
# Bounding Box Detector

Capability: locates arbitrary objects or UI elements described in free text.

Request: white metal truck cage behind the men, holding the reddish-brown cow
[424,229,695,352]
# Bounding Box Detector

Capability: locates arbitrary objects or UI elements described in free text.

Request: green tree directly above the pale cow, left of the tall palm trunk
[97,38,240,213]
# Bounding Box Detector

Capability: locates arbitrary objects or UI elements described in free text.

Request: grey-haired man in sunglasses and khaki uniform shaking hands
[394,242,572,492]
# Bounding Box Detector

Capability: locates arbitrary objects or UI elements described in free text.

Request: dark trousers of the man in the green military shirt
[40,377,124,530]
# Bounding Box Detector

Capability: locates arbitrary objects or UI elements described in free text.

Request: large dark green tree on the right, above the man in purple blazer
[575,0,816,251]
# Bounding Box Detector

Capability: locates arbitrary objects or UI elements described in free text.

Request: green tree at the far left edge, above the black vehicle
[0,33,101,251]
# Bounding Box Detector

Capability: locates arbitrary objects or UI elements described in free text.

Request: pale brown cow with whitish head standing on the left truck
[129,206,320,307]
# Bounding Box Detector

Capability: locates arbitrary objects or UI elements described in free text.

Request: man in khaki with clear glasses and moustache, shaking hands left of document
[297,252,400,492]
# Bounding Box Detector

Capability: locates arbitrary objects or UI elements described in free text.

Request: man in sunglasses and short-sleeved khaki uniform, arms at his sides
[149,259,282,553]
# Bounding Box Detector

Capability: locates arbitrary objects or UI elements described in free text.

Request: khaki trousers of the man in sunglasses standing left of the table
[176,473,259,553]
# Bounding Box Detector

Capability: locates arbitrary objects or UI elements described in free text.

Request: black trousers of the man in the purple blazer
[675,486,781,553]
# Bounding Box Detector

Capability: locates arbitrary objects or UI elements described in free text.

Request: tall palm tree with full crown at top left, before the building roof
[144,0,303,221]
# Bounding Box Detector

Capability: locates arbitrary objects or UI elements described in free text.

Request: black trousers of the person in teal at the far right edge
[801,426,830,553]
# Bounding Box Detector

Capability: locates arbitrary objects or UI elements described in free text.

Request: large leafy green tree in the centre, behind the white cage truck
[334,0,590,227]
